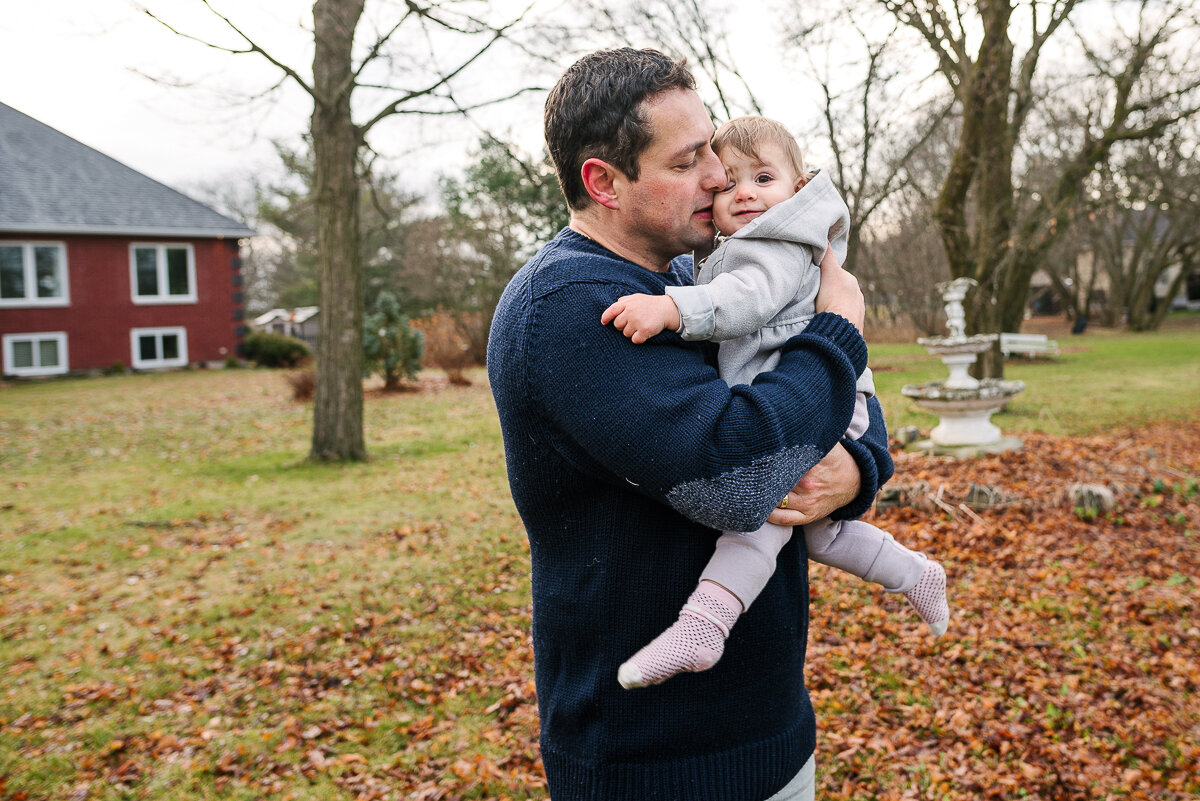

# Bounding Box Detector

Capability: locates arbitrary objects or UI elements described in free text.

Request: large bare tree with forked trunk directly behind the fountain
[875,0,1200,375]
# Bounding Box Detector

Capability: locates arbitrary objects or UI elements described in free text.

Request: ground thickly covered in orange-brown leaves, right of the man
[808,423,1200,800]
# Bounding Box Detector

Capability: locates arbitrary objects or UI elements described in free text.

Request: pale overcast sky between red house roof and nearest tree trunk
[0,0,348,193]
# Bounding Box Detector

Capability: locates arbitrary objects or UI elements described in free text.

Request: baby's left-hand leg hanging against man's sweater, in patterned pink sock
[617,523,792,689]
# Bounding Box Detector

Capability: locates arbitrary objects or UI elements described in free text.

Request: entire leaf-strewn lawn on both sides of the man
[0,331,1200,801]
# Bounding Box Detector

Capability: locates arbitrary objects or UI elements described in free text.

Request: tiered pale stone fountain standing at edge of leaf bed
[900,278,1025,456]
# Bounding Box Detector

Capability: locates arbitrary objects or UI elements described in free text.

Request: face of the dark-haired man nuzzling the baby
[620,89,725,269]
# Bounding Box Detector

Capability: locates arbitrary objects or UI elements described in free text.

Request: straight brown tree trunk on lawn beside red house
[310,0,366,460]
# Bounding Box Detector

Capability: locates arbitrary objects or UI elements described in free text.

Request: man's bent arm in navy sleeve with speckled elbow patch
[529,283,874,531]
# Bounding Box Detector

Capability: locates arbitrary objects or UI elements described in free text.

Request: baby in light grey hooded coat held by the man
[601,116,950,688]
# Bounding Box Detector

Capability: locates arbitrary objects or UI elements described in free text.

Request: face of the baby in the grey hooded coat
[713,143,804,236]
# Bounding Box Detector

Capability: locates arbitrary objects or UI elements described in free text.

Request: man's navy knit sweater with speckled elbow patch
[487,229,892,801]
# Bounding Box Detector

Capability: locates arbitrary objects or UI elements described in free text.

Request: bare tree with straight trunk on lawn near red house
[146,0,522,460]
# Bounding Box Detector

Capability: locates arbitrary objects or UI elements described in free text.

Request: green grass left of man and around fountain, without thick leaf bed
[0,323,1200,801]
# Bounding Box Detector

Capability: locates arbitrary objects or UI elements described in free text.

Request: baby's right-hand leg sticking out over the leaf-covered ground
[804,518,950,637]
